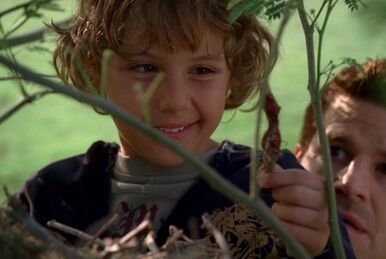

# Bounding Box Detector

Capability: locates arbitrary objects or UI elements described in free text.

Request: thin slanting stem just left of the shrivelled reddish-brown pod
[249,1,291,199]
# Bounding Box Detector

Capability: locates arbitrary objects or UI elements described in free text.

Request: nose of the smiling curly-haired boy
[154,76,191,113]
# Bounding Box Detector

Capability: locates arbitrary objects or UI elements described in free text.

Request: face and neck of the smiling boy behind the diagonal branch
[107,31,231,166]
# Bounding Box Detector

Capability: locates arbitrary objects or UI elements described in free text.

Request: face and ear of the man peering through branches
[297,95,386,259]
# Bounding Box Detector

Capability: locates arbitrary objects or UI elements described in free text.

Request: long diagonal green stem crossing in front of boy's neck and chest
[0,55,310,258]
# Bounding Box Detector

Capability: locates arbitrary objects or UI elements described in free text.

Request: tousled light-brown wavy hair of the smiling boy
[54,0,272,109]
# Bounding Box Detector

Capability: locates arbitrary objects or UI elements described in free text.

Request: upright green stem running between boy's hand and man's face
[298,0,346,259]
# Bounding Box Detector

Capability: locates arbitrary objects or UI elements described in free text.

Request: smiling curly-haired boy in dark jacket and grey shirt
[19,0,350,258]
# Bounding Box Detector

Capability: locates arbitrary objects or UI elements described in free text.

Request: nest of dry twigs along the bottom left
[0,196,228,259]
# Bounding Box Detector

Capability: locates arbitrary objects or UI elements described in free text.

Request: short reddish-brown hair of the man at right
[299,59,386,150]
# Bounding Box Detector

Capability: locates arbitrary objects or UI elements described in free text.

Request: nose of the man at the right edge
[335,159,372,202]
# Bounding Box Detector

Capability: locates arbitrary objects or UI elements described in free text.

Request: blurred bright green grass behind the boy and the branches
[0,0,386,202]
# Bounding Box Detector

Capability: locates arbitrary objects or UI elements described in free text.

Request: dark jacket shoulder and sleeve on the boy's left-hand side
[18,141,119,234]
